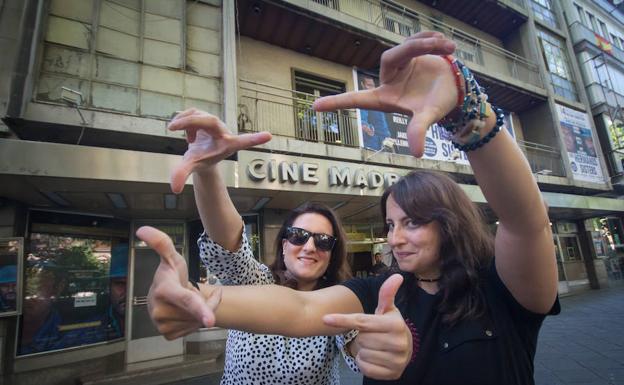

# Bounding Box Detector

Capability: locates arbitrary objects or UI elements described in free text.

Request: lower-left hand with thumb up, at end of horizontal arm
[136,226,221,340]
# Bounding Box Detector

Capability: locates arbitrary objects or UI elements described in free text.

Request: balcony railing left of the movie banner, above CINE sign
[238,79,359,147]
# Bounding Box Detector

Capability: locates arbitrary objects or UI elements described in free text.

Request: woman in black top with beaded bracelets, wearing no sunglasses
[143,32,559,385]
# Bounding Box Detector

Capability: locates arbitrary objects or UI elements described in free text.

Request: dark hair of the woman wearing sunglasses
[269,203,351,290]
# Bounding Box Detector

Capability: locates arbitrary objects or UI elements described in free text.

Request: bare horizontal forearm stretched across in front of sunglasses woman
[201,285,362,337]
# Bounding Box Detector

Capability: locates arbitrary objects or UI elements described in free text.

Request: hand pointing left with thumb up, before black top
[323,274,414,380]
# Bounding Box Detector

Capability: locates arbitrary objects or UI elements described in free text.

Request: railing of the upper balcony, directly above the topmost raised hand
[312,0,544,88]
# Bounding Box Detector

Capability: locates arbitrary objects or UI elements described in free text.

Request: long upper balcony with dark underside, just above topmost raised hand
[238,0,546,112]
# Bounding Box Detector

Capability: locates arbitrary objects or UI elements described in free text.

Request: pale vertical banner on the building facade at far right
[557,104,604,183]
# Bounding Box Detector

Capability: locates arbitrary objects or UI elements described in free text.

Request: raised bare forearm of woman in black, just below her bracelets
[467,103,548,233]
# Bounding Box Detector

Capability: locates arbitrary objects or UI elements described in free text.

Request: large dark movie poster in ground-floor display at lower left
[17,233,128,355]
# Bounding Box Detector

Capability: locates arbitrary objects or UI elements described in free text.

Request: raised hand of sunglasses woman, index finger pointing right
[168,108,271,193]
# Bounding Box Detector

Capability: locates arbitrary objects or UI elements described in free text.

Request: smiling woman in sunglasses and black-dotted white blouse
[149,109,355,385]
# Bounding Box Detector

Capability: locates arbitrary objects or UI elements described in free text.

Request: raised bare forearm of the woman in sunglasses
[193,165,243,251]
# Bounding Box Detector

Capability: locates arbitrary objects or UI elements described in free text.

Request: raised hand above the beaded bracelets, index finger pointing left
[314,31,458,157]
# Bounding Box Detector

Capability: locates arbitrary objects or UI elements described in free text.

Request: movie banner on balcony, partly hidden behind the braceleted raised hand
[355,70,515,165]
